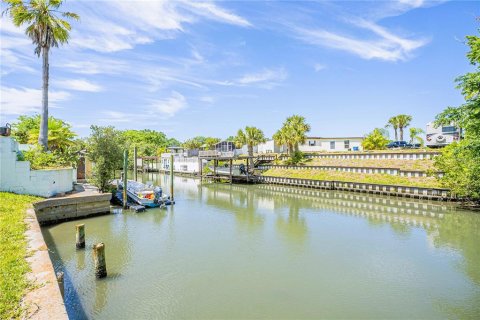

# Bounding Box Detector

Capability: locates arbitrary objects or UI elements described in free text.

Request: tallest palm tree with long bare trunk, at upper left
[3,0,79,150]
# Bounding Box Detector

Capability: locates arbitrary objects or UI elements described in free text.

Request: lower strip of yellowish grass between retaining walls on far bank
[263,169,441,188]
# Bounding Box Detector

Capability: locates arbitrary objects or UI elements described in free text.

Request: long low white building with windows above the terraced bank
[298,137,363,152]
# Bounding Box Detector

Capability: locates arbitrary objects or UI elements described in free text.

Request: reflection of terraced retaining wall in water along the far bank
[205,184,454,229]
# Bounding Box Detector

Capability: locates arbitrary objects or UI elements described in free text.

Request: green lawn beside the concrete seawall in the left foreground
[0,192,40,319]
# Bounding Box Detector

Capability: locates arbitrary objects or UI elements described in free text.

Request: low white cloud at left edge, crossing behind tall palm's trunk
[0,86,70,115]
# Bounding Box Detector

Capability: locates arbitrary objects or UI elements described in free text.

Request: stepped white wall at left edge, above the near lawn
[0,137,76,197]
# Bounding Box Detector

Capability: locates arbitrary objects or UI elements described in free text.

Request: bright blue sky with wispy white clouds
[0,0,480,140]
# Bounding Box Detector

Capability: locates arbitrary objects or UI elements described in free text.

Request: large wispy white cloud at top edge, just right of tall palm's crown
[71,1,251,52]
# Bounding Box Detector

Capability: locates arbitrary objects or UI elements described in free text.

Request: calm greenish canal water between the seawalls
[42,174,480,319]
